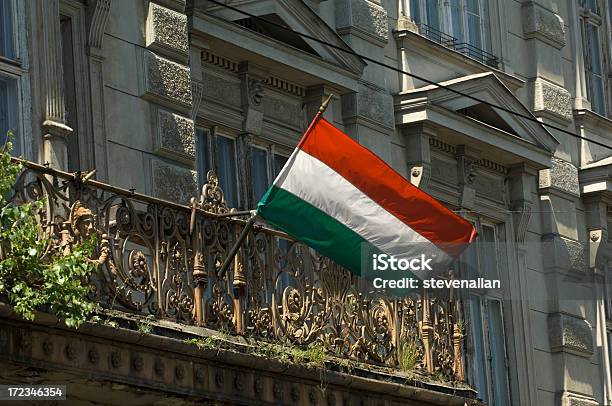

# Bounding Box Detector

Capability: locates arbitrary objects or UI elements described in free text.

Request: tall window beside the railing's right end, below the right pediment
[462,221,511,406]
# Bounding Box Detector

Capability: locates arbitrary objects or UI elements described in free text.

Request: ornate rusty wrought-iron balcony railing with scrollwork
[4,162,463,380]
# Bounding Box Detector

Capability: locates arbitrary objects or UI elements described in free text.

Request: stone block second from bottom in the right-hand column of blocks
[548,313,593,358]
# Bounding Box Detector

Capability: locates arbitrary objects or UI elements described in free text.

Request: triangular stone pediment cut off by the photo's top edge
[200,0,366,75]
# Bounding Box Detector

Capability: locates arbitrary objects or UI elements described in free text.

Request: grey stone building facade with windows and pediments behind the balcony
[0,0,612,405]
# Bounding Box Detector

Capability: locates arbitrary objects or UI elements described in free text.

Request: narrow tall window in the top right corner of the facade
[581,0,607,116]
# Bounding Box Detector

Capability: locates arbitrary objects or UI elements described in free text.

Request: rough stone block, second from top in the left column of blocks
[143,51,192,112]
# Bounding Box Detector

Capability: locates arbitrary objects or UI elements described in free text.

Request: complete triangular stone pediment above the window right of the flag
[396,72,559,153]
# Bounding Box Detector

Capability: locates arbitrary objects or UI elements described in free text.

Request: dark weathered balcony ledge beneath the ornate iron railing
[0,302,481,406]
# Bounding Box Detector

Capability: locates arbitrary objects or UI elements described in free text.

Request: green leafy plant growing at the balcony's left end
[0,137,96,328]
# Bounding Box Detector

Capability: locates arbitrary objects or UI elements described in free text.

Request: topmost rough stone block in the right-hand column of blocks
[522,1,566,49]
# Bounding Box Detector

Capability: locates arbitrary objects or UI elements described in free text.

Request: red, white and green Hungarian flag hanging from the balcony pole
[257,114,476,279]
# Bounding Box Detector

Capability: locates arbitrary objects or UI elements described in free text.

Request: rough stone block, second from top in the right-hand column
[530,78,572,124]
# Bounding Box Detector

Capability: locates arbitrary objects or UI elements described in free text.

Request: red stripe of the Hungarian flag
[299,118,476,256]
